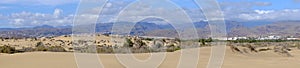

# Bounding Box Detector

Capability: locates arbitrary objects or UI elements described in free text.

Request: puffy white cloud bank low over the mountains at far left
[2,9,74,27]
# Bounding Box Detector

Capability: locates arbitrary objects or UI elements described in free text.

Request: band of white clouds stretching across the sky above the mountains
[0,0,300,26]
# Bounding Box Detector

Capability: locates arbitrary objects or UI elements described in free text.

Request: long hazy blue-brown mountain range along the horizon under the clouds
[0,21,300,38]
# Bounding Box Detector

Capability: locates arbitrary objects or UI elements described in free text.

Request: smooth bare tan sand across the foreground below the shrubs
[0,47,300,68]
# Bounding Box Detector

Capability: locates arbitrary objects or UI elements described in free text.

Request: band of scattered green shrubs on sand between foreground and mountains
[0,35,300,56]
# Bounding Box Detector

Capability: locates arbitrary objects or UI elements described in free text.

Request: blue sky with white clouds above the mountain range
[0,0,300,28]
